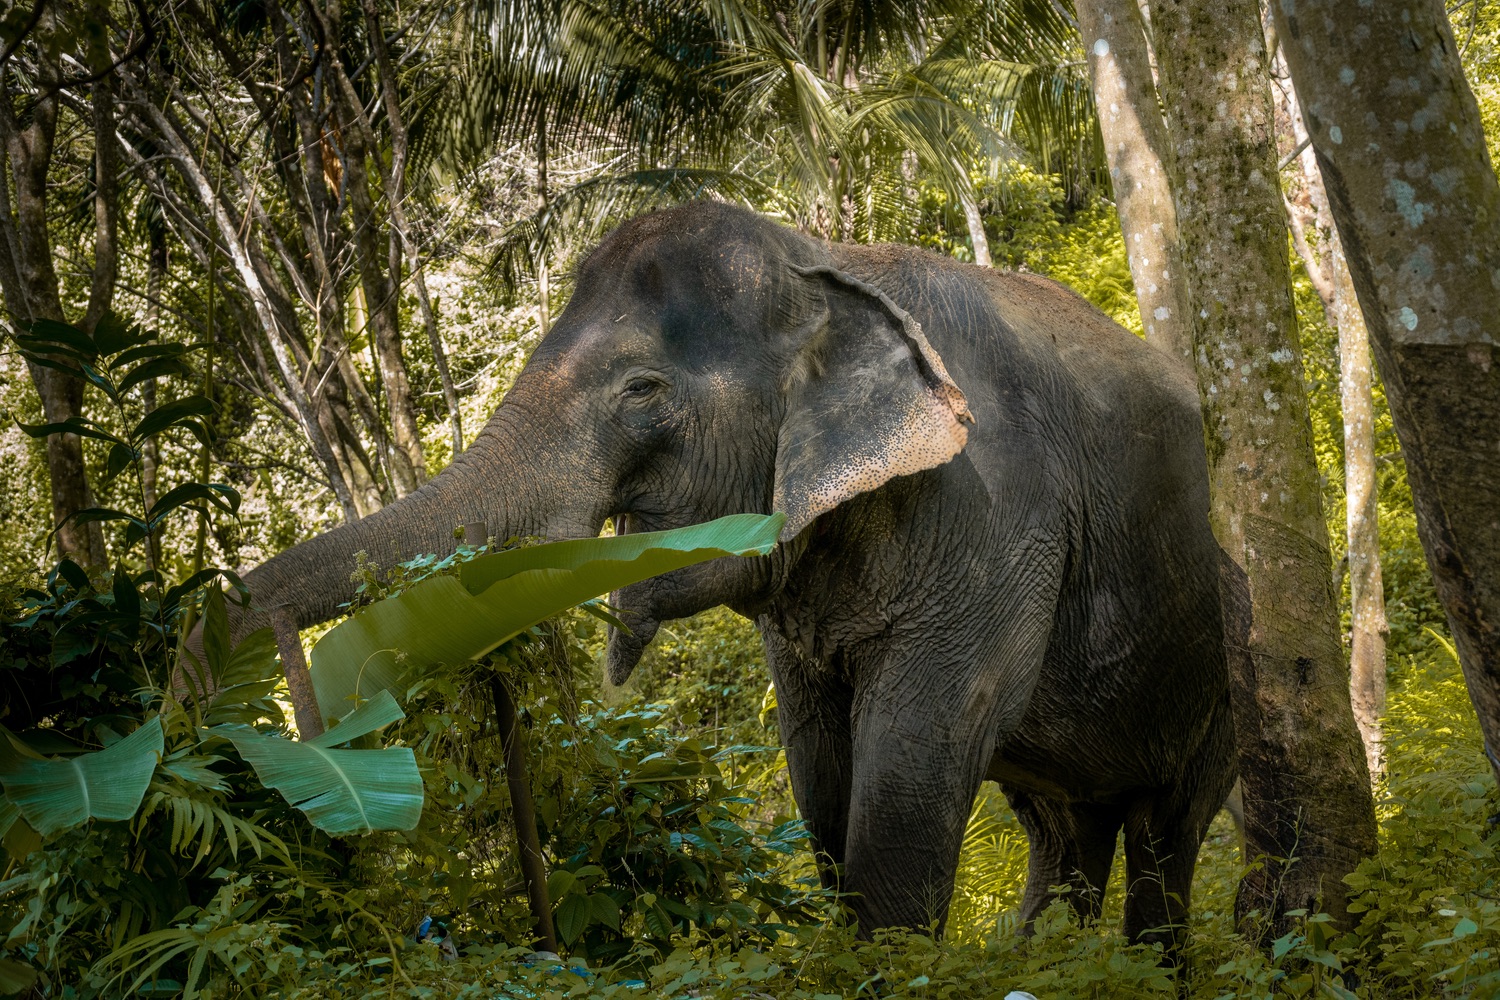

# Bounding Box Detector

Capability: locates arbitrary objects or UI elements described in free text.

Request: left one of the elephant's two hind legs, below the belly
[1001,786,1125,930]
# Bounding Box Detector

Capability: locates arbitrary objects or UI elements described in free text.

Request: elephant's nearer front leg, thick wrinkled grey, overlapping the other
[843,627,1047,936]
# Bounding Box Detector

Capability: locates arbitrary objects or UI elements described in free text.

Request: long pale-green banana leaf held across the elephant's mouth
[312,514,786,715]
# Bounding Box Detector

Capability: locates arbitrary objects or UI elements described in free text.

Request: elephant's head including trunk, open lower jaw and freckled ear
[239,202,971,682]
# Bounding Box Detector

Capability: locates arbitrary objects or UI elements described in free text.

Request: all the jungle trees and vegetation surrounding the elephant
[0,0,1500,999]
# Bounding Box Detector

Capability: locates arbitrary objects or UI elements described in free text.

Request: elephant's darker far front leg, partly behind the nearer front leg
[761,624,854,889]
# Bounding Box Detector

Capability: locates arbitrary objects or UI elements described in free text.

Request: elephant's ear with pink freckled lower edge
[776,267,974,541]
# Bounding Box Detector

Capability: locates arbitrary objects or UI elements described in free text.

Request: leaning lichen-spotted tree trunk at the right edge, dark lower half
[1272,0,1500,777]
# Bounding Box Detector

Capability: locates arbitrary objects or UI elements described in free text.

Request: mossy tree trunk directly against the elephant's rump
[1151,0,1376,940]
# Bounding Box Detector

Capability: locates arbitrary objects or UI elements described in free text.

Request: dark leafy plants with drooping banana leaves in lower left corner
[0,332,438,997]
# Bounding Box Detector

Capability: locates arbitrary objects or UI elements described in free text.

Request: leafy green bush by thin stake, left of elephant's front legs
[537,708,825,961]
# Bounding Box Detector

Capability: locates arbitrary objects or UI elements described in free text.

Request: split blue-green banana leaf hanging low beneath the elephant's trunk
[212,691,422,837]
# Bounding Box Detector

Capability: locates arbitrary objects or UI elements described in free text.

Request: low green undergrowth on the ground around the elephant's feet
[255,632,1500,1000]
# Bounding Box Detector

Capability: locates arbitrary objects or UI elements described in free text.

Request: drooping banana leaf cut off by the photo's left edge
[0,718,164,837]
